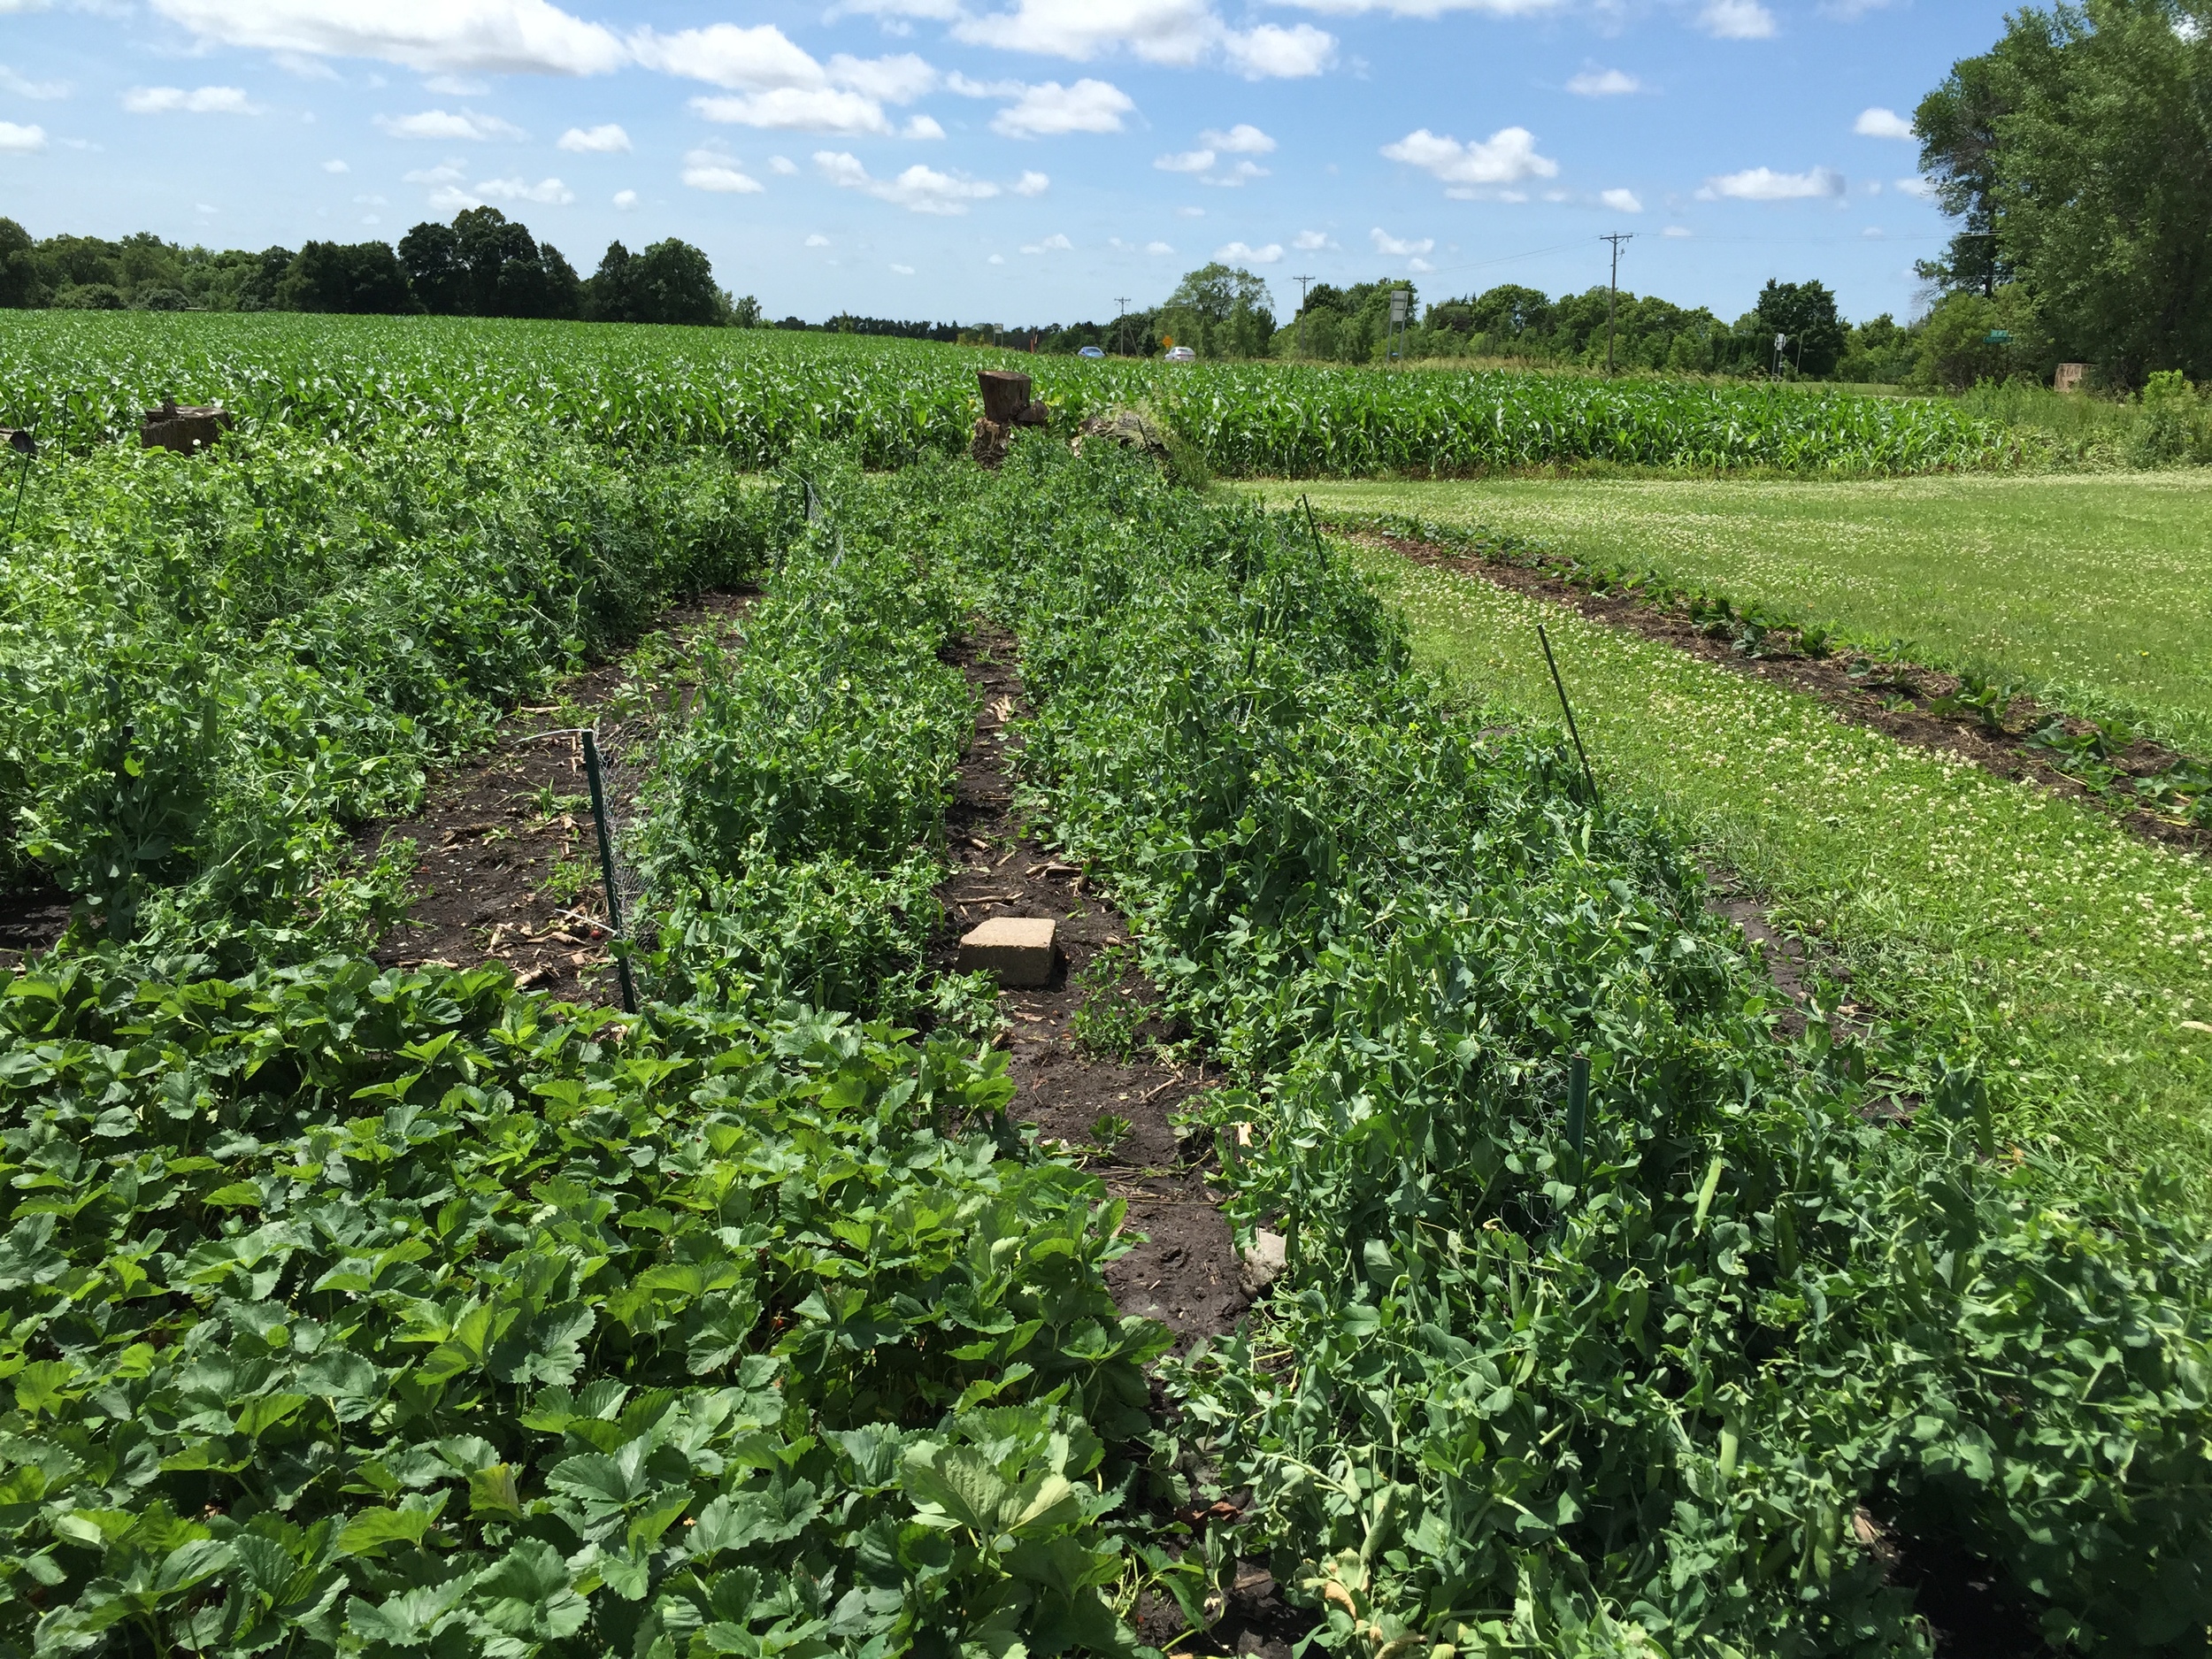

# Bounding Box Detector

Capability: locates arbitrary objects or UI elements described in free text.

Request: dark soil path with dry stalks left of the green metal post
[361,593,752,1004]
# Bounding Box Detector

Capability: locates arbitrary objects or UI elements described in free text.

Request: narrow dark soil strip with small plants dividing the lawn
[1363,535,2212,872]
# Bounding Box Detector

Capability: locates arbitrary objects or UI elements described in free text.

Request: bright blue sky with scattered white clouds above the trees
[0,0,2004,326]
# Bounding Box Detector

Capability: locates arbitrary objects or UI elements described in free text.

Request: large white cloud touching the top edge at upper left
[150,0,626,75]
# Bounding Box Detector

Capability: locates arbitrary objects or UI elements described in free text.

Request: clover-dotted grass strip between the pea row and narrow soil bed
[1292,540,2212,1208]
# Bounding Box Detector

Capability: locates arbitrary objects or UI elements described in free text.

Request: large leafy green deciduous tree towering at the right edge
[1914,0,2212,385]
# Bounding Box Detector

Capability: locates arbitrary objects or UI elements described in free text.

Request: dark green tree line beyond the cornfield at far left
[0,208,761,327]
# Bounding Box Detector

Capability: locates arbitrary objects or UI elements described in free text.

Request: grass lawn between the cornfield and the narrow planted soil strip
[1256,469,2212,755]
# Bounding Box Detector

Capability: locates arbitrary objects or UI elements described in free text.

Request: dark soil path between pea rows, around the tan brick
[929,635,1250,1352]
